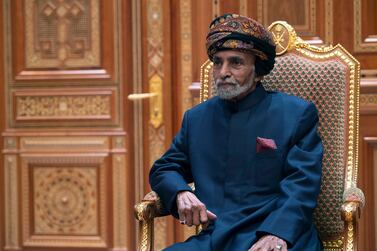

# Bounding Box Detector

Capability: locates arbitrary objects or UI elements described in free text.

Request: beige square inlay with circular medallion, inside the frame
[33,167,98,235]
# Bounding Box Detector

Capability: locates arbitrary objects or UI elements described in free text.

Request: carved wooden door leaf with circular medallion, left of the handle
[0,0,135,251]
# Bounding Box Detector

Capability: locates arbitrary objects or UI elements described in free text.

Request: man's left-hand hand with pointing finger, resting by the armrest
[177,191,217,229]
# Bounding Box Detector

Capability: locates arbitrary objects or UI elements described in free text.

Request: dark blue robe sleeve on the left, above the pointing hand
[149,111,193,218]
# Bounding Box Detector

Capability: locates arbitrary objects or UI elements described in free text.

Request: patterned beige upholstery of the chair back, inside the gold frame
[263,53,348,238]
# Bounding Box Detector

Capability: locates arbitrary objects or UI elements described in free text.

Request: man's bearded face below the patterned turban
[213,50,255,99]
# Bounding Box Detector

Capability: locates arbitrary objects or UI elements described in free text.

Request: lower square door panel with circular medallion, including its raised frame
[21,154,108,247]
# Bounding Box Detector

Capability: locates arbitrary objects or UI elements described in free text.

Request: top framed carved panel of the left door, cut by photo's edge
[11,0,117,81]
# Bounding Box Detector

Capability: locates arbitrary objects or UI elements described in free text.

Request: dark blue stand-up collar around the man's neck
[219,82,267,113]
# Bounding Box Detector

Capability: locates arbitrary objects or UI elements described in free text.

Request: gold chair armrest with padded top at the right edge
[341,187,365,250]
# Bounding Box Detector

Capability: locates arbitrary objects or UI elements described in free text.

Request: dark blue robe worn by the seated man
[150,84,323,251]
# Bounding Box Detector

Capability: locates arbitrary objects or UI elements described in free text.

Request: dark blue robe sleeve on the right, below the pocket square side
[257,103,323,245]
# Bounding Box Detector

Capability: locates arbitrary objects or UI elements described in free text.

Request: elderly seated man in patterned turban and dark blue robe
[150,14,323,251]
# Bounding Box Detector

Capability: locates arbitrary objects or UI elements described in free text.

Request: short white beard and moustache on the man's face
[213,71,255,99]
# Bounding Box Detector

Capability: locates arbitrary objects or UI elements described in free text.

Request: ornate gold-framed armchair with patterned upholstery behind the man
[135,21,364,251]
